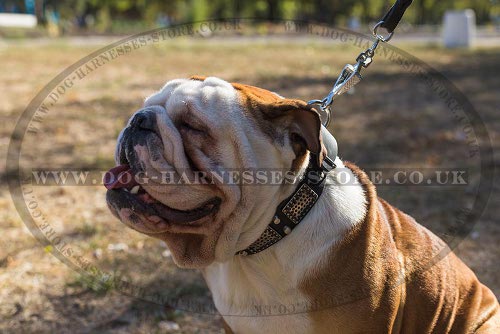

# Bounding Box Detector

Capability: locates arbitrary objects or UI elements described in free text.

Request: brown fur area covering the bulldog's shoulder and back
[300,163,500,334]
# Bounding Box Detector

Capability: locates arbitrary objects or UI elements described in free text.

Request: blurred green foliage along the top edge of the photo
[40,0,500,26]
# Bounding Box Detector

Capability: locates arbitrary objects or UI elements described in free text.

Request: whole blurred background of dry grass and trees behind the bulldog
[0,0,500,333]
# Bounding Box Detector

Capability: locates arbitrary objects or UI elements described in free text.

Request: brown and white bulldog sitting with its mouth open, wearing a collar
[105,77,500,334]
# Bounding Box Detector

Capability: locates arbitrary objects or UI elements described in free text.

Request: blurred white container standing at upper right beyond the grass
[443,9,476,48]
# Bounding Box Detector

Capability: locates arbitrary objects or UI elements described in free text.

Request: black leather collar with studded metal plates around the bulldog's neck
[236,126,337,256]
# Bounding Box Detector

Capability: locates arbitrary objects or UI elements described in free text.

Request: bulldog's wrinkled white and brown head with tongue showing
[105,77,326,267]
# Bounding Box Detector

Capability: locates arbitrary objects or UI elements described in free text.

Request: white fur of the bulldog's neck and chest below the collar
[203,158,366,330]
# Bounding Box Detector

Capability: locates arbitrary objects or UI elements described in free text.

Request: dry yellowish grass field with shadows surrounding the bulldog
[0,34,500,333]
